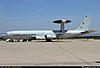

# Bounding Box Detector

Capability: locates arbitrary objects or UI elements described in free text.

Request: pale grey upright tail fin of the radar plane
[76,16,90,30]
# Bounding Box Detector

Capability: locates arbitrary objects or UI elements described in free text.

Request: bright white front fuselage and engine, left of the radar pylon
[7,30,57,39]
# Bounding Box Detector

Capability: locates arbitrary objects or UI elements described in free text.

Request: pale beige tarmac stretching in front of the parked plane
[0,39,100,66]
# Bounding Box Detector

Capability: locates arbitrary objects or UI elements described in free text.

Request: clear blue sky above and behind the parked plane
[0,0,100,33]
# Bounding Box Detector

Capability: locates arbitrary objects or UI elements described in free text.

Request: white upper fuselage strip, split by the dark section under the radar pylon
[7,30,85,35]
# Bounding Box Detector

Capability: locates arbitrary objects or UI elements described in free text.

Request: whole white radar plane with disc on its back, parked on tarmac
[3,16,95,42]
